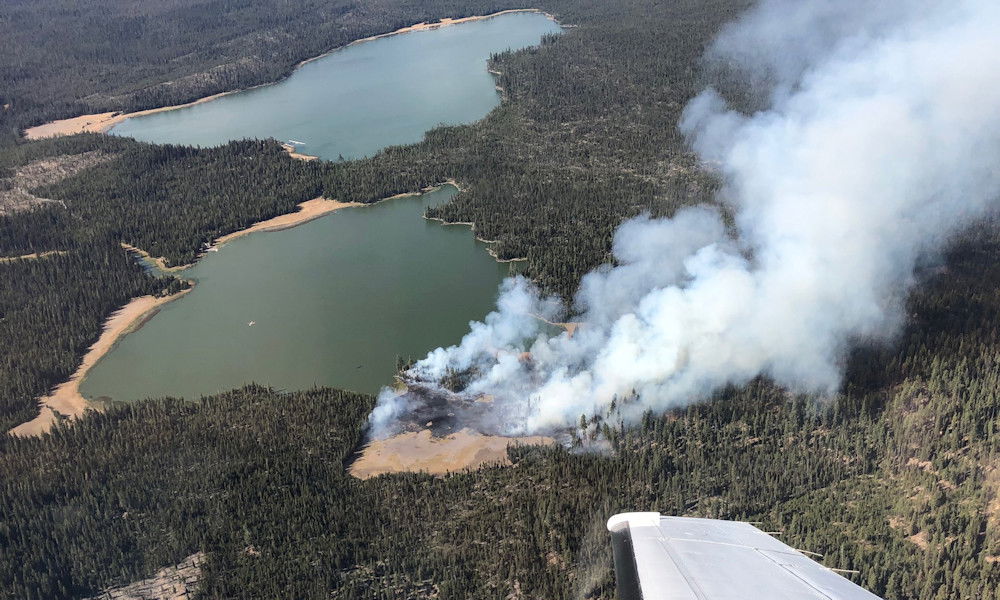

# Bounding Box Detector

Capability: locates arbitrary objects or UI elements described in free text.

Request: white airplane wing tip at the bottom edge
[608,512,881,600]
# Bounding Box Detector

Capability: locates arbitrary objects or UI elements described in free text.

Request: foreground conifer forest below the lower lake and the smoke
[0,227,1000,600]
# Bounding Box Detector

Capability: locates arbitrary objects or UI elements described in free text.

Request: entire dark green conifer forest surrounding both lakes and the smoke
[0,0,1000,600]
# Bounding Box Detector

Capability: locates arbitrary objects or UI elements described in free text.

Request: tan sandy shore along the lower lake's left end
[9,288,190,437]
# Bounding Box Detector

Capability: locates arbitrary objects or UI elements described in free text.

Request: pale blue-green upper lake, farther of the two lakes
[111,13,560,160]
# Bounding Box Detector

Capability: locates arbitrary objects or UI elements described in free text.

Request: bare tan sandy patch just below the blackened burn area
[350,429,555,479]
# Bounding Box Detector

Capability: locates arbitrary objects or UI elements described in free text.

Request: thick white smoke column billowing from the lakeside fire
[372,0,1000,433]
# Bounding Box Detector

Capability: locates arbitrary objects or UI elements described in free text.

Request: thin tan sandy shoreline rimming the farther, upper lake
[24,8,555,142]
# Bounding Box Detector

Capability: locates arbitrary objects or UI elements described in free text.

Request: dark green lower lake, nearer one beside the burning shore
[80,185,508,400]
